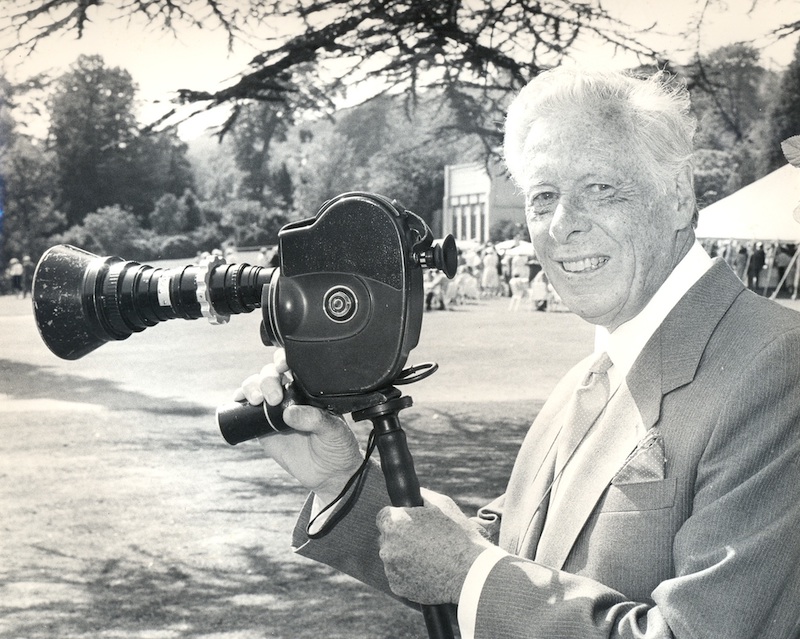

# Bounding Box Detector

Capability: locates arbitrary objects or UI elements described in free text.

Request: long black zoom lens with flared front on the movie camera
[33,245,277,359]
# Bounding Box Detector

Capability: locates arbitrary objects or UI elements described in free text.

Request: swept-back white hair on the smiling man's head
[504,67,696,199]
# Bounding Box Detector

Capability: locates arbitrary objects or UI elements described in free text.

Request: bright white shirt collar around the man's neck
[595,241,713,389]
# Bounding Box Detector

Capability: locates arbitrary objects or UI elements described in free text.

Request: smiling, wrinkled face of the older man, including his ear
[518,107,693,330]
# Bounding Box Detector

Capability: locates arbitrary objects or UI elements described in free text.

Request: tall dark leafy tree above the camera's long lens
[49,56,193,224]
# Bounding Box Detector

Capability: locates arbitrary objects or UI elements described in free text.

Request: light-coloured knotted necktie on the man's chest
[555,353,613,482]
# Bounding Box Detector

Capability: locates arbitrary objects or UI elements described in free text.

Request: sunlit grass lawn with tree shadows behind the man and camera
[0,288,592,639]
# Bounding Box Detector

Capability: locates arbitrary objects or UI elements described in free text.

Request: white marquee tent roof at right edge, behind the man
[697,164,800,243]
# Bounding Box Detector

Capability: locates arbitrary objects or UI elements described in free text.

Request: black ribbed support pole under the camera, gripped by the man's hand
[353,396,453,639]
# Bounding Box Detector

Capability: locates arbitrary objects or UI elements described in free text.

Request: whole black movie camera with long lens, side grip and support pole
[33,192,458,637]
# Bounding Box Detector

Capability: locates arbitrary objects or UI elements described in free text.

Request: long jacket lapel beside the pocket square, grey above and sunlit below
[532,260,744,568]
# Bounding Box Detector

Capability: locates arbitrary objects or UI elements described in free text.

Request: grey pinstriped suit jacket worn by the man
[295,261,800,639]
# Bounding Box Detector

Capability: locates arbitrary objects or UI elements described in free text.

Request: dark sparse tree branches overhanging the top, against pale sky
[4,0,658,144]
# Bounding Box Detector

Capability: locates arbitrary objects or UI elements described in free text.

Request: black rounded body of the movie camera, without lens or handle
[261,194,430,398]
